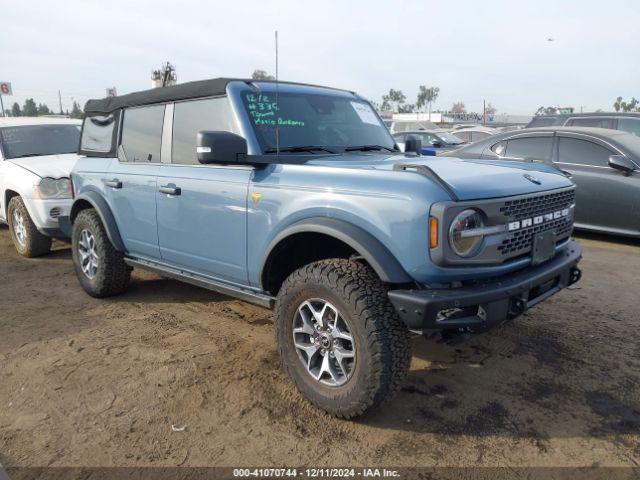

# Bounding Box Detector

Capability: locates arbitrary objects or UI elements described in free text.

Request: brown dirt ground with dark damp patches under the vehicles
[0,227,640,467]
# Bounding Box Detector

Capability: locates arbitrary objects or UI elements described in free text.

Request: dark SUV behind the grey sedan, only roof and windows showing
[526,112,640,135]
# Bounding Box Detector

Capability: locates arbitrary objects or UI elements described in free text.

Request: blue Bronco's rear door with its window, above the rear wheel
[104,105,165,259]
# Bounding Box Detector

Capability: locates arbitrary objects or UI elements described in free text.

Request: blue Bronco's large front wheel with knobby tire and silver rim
[276,259,410,418]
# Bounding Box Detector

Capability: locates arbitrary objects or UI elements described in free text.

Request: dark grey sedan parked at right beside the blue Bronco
[445,127,640,237]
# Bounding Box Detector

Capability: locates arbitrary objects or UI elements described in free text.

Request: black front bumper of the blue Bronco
[389,240,582,332]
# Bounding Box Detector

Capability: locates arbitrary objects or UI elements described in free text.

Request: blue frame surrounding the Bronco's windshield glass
[232,81,396,156]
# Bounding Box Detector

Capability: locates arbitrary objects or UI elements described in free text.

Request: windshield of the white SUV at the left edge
[0,125,80,159]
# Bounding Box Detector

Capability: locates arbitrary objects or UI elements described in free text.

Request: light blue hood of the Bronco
[309,155,573,200]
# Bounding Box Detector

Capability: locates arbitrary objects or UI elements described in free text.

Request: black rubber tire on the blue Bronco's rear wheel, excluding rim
[71,208,132,298]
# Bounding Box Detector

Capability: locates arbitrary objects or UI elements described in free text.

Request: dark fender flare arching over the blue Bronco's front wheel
[259,217,413,283]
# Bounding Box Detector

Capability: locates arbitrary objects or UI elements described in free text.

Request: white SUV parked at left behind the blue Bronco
[0,117,81,257]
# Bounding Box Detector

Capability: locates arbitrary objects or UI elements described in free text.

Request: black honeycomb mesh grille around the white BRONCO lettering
[498,190,575,258]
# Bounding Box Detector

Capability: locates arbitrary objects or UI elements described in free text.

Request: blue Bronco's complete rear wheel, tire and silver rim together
[71,209,131,297]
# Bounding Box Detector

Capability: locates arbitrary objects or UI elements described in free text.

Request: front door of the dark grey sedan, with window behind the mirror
[556,133,640,234]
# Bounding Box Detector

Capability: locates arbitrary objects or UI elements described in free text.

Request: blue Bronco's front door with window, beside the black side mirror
[156,97,253,285]
